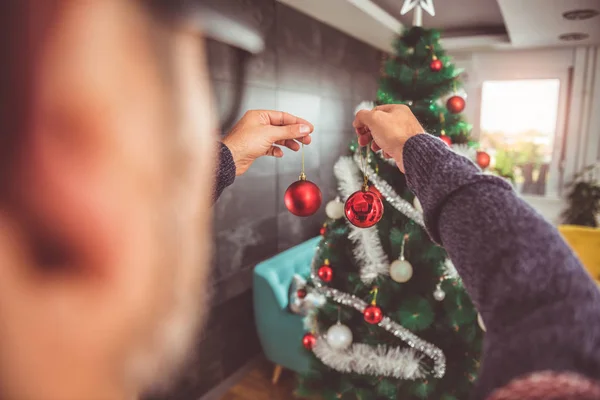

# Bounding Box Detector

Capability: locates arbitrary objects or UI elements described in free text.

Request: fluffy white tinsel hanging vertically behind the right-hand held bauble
[333,157,390,285]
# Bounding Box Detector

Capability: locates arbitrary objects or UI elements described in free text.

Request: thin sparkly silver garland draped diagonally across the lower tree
[311,255,446,378]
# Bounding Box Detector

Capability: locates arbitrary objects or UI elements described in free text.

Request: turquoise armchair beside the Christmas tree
[254,236,321,383]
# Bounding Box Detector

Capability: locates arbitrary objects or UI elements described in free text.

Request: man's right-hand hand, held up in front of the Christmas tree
[352,104,424,172]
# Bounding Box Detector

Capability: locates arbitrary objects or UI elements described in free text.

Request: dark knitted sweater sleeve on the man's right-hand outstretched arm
[403,134,600,399]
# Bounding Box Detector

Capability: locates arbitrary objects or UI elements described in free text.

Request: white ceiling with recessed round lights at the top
[278,0,600,51]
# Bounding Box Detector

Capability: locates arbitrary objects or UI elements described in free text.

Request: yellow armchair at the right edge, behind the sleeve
[558,225,600,284]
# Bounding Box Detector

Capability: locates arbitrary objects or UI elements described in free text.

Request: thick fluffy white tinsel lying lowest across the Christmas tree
[313,336,426,380]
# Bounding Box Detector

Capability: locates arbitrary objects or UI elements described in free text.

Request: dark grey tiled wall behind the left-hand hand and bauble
[155,0,381,400]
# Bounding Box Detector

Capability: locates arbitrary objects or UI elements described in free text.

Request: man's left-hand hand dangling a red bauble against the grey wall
[223,110,314,175]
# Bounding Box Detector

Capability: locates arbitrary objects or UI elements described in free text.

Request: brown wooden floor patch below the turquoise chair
[221,360,314,400]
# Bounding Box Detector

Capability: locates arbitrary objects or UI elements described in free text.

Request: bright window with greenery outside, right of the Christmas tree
[480,79,560,196]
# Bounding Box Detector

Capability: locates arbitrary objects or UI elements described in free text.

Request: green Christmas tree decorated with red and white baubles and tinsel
[298,27,489,400]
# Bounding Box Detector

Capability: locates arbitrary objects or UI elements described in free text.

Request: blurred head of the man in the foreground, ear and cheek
[0,0,214,400]
